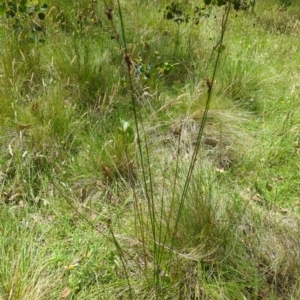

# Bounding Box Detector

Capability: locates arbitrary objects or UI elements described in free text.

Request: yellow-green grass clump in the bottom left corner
[0,207,61,299]
